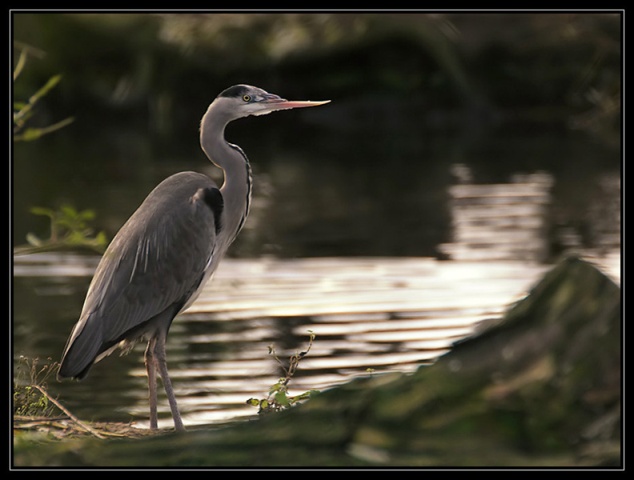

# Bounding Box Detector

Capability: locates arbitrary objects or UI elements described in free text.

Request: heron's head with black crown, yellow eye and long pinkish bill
[214,85,330,118]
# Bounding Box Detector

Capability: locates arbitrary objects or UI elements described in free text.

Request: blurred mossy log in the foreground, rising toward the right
[14,258,622,467]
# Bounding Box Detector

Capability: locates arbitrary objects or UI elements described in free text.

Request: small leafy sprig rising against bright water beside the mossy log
[247,330,319,414]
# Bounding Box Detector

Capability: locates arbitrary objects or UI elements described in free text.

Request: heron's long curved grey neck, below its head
[200,108,251,249]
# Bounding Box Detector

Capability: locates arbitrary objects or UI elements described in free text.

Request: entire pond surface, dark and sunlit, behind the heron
[12,97,621,426]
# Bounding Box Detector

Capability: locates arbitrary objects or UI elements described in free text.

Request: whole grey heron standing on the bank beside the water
[58,85,329,430]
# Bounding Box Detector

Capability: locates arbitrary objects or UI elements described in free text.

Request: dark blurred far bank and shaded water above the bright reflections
[12,12,622,257]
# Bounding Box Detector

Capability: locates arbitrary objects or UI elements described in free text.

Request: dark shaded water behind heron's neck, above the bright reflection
[13,101,620,258]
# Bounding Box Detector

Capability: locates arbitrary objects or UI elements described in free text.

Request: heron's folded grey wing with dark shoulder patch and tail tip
[60,172,222,376]
